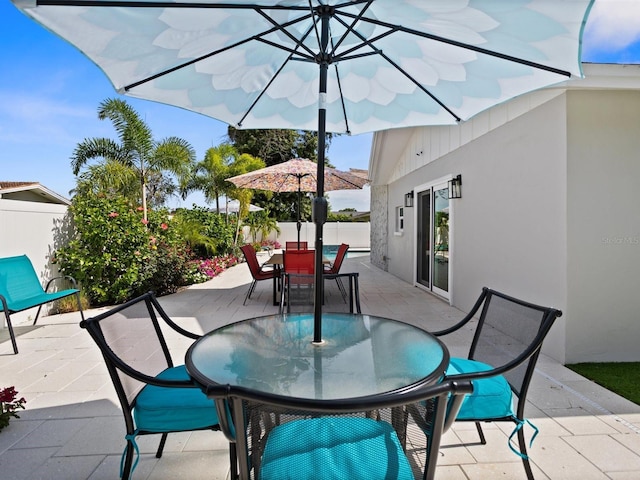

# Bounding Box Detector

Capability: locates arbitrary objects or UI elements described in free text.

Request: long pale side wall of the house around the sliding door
[380,94,568,361]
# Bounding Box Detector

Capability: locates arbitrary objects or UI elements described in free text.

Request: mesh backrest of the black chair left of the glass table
[80,292,198,406]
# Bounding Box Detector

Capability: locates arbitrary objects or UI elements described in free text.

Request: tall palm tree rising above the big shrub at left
[71,98,195,220]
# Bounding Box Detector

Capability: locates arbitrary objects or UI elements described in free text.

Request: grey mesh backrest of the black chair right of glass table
[469,287,562,408]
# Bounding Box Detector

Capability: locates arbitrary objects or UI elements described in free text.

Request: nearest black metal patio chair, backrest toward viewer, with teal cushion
[207,382,472,480]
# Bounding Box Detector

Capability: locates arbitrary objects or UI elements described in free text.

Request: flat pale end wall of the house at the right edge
[566,90,640,363]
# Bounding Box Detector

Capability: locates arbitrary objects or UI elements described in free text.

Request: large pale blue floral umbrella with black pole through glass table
[12,0,593,341]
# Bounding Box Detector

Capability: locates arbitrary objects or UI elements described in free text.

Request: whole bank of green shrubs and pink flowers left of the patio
[56,195,237,306]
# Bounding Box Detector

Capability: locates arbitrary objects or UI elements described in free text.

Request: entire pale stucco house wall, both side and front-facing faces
[370,66,640,363]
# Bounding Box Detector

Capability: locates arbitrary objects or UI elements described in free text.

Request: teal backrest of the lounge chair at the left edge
[0,255,44,309]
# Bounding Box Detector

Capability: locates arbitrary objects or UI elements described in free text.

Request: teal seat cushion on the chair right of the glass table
[447,357,515,420]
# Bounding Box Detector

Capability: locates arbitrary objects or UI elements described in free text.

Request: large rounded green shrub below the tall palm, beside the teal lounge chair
[56,195,187,306]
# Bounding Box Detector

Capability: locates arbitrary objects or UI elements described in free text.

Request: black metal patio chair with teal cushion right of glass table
[432,287,562,480]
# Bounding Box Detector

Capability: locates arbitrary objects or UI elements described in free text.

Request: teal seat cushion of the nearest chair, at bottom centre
[260,417,414,480]
